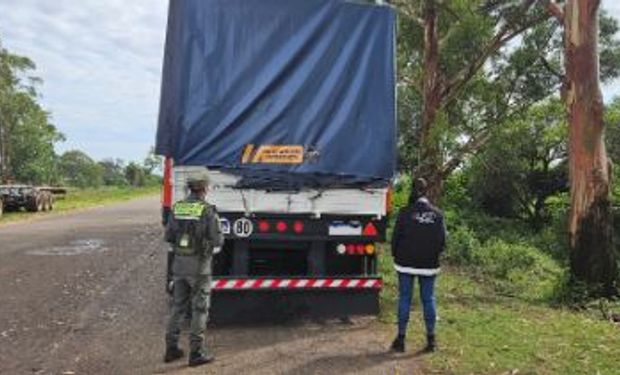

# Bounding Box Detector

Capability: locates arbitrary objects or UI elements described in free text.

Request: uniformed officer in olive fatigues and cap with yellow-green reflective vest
[164,176,224,367]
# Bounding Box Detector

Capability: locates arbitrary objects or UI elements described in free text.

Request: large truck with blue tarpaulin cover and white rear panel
[156,0,396,319]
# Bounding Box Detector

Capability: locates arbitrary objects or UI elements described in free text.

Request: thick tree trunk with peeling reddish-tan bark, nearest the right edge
[564,0,618,295]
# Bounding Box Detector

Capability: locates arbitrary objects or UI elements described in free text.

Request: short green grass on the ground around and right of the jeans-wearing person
[381,252,620,374]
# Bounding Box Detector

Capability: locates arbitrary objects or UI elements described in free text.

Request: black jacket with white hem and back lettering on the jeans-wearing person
[392,197,446,276]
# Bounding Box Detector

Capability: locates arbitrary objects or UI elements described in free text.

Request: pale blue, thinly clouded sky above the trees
[0,0,620,160]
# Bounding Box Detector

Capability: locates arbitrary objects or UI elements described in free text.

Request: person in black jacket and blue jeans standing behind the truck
[391,178,446,352]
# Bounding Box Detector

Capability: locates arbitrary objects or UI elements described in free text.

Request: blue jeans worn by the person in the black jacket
[398,272,437,336]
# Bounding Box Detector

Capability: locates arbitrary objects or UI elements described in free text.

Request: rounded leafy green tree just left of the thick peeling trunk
[468,100,568,229]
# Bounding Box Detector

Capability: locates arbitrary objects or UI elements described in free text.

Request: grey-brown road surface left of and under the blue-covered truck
[0,198,419,375]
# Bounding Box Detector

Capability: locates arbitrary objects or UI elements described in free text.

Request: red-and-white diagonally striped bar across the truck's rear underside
[211,277,383,293]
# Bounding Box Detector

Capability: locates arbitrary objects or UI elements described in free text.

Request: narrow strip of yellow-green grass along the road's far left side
[0,186,160,225]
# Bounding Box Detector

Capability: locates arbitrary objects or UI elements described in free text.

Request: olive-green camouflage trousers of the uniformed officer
[166,275,211,352]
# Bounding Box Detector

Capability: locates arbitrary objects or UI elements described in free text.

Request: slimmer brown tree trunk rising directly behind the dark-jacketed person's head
[414,0,443,201]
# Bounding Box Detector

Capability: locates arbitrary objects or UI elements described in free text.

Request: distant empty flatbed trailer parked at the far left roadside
[0,184,66,215]
